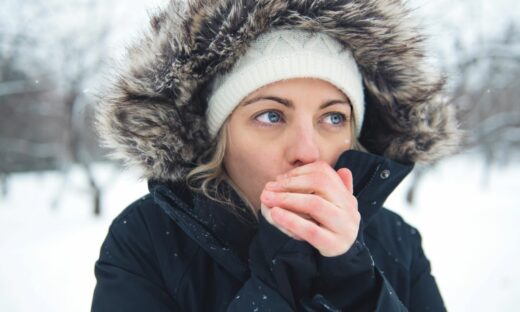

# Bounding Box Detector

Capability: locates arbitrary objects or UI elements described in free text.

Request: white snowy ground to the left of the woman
[0,164,147,311]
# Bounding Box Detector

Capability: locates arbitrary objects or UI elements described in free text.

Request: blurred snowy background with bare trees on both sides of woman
[0,0,520,311]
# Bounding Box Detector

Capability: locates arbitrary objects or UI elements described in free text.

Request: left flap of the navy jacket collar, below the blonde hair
[148,180,256,282]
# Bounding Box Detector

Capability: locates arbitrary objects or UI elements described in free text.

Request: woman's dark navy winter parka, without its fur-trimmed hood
[92,151,445,312]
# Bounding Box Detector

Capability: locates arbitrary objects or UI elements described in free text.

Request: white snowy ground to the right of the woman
[387,155,520,311]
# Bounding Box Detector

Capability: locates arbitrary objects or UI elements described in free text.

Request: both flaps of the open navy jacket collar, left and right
[148,151,413,280]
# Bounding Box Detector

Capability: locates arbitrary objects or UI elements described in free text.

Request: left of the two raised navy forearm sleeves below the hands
[228,215,317,312]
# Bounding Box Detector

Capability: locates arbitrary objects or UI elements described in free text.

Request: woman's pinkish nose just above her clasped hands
[286,123,320,167]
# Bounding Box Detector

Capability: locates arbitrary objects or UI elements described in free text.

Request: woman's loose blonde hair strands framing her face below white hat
[186,116,366,219]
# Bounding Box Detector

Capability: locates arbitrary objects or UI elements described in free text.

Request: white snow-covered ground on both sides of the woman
[0,155,520,312]
